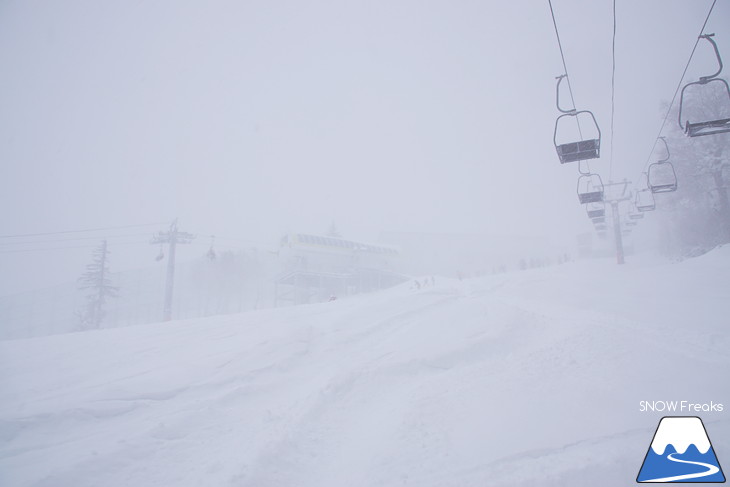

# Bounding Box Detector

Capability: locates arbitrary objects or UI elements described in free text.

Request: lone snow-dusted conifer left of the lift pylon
[78,240,119,330]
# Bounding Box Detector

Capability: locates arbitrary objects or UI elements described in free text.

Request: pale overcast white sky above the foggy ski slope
[0,0,730,294]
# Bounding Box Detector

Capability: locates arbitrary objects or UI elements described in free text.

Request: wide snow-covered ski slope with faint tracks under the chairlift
[0,246,730,487]
